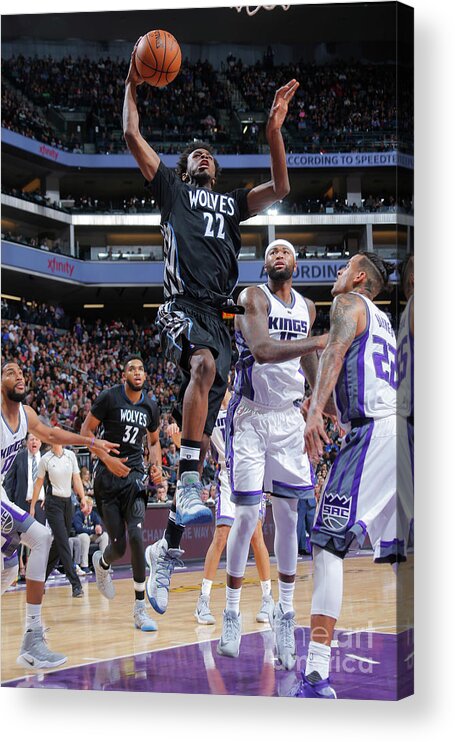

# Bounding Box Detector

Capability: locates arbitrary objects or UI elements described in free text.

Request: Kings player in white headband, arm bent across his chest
[217,239,327,670]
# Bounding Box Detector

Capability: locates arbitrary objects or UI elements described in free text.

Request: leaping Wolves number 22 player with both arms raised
[123,40,299,613]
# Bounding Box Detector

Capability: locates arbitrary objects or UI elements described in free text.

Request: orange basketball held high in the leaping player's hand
[136,30,182,88]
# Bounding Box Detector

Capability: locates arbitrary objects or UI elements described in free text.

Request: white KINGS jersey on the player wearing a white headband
[234,284,310,409]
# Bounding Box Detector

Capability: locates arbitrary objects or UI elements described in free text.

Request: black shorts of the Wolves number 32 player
[93,465,147,536]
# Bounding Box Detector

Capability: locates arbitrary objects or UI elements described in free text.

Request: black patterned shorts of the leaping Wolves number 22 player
[156,297,232,436]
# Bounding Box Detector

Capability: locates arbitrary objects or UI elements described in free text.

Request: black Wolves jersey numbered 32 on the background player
[90,384,160,470]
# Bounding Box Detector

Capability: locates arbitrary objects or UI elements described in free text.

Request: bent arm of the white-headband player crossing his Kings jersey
[235,286,327,363]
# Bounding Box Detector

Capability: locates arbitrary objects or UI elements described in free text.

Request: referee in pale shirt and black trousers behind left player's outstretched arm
[30,444,86,598]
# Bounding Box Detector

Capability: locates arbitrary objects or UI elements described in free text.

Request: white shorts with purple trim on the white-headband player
[226,397,314,505]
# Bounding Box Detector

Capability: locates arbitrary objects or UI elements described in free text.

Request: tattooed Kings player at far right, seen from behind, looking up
[293,252,400,698]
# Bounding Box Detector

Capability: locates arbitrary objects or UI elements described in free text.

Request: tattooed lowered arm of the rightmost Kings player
[305,293,365,461]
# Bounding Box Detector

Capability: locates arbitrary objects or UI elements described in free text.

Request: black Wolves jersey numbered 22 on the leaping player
[147,162,250,307]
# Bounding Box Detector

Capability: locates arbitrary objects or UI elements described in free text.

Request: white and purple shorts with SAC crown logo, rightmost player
[311,416,406,563]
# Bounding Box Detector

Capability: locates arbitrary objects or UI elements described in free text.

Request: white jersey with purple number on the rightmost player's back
[334,292,398,423]
